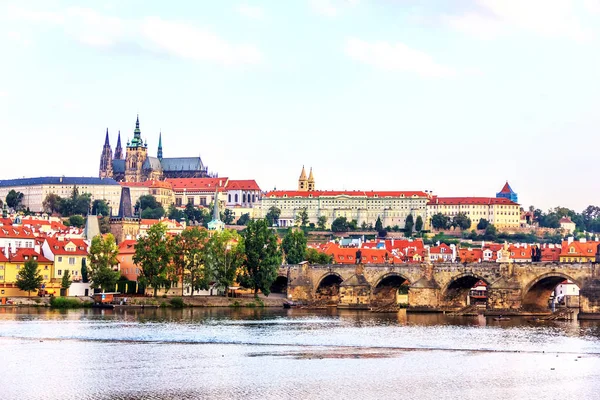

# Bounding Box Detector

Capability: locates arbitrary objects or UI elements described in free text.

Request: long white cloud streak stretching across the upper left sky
[5,7,262,66]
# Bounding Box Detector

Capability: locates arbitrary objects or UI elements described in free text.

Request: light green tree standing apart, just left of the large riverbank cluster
[88,233,120,292]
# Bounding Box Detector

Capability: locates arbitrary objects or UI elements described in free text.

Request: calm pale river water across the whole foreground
[0,308,600,400]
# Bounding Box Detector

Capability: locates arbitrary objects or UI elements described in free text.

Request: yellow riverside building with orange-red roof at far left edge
[0,248,60,296]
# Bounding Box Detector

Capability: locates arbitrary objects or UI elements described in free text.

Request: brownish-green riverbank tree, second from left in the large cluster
[169,227,211,296]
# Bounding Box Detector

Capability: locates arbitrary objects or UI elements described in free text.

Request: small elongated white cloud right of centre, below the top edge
[345,38,456,77]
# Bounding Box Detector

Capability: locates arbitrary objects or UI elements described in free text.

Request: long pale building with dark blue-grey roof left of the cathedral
[0,176,121,215]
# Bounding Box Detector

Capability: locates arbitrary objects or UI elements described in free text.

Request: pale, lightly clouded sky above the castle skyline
[0,0,600,211]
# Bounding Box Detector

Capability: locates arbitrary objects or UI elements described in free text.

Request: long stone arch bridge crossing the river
[273,262,600,317]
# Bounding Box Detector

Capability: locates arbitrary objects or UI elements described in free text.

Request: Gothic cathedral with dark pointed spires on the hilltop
[100,116,213,182]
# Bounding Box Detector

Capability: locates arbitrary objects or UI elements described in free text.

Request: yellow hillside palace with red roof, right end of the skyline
[427,197,521,229]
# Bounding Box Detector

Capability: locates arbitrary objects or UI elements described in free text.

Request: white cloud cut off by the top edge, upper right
[442,0,590,40]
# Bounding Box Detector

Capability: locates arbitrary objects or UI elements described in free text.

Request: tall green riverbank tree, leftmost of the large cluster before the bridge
[133,224,172,297]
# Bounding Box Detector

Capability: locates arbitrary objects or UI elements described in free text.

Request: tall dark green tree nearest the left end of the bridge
[239,219,281,296]
